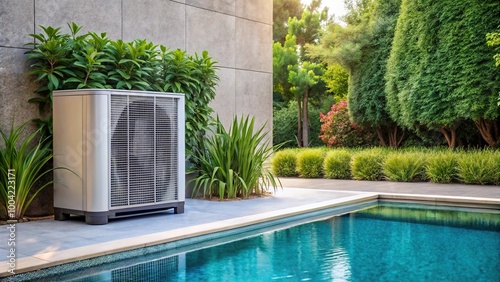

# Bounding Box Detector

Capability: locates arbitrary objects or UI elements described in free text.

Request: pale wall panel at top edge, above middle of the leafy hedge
[123,0,186,49]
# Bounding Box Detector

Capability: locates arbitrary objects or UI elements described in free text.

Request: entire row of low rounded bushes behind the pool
[271,148,500,185]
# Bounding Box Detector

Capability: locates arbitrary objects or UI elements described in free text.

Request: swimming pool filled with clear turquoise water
[6,203,500,281]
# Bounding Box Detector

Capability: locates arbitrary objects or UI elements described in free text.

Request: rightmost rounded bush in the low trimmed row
[458,150,499,185]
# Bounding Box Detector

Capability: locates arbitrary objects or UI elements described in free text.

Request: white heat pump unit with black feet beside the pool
[53,89,185,224]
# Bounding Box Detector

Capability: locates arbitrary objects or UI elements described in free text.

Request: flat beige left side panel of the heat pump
[53,96,85,210]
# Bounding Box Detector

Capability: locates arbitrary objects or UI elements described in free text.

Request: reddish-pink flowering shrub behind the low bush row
[319,100,373,147]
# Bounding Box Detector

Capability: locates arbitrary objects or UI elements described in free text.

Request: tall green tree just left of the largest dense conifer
[308,0,402,147]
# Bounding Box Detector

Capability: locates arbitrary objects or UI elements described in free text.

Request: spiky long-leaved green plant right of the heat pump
[192,116,280,200]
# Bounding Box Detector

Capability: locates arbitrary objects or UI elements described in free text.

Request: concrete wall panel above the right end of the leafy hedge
[186,6,235,68]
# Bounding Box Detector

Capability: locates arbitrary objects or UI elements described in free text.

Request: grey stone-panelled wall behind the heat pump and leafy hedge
[0,0,272,215]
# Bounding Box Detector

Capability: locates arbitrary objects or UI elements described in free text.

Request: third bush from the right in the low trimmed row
[383,153,425,182]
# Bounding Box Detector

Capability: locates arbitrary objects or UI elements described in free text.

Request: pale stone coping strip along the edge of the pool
[0,192,500,277]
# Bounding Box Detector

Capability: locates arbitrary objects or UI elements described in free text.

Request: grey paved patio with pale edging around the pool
[0,178,500,277]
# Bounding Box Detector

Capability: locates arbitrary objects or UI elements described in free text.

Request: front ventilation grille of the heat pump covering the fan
[110,95,178,207]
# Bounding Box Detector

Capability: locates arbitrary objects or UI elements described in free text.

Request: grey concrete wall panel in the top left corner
[0,0,35,48]
